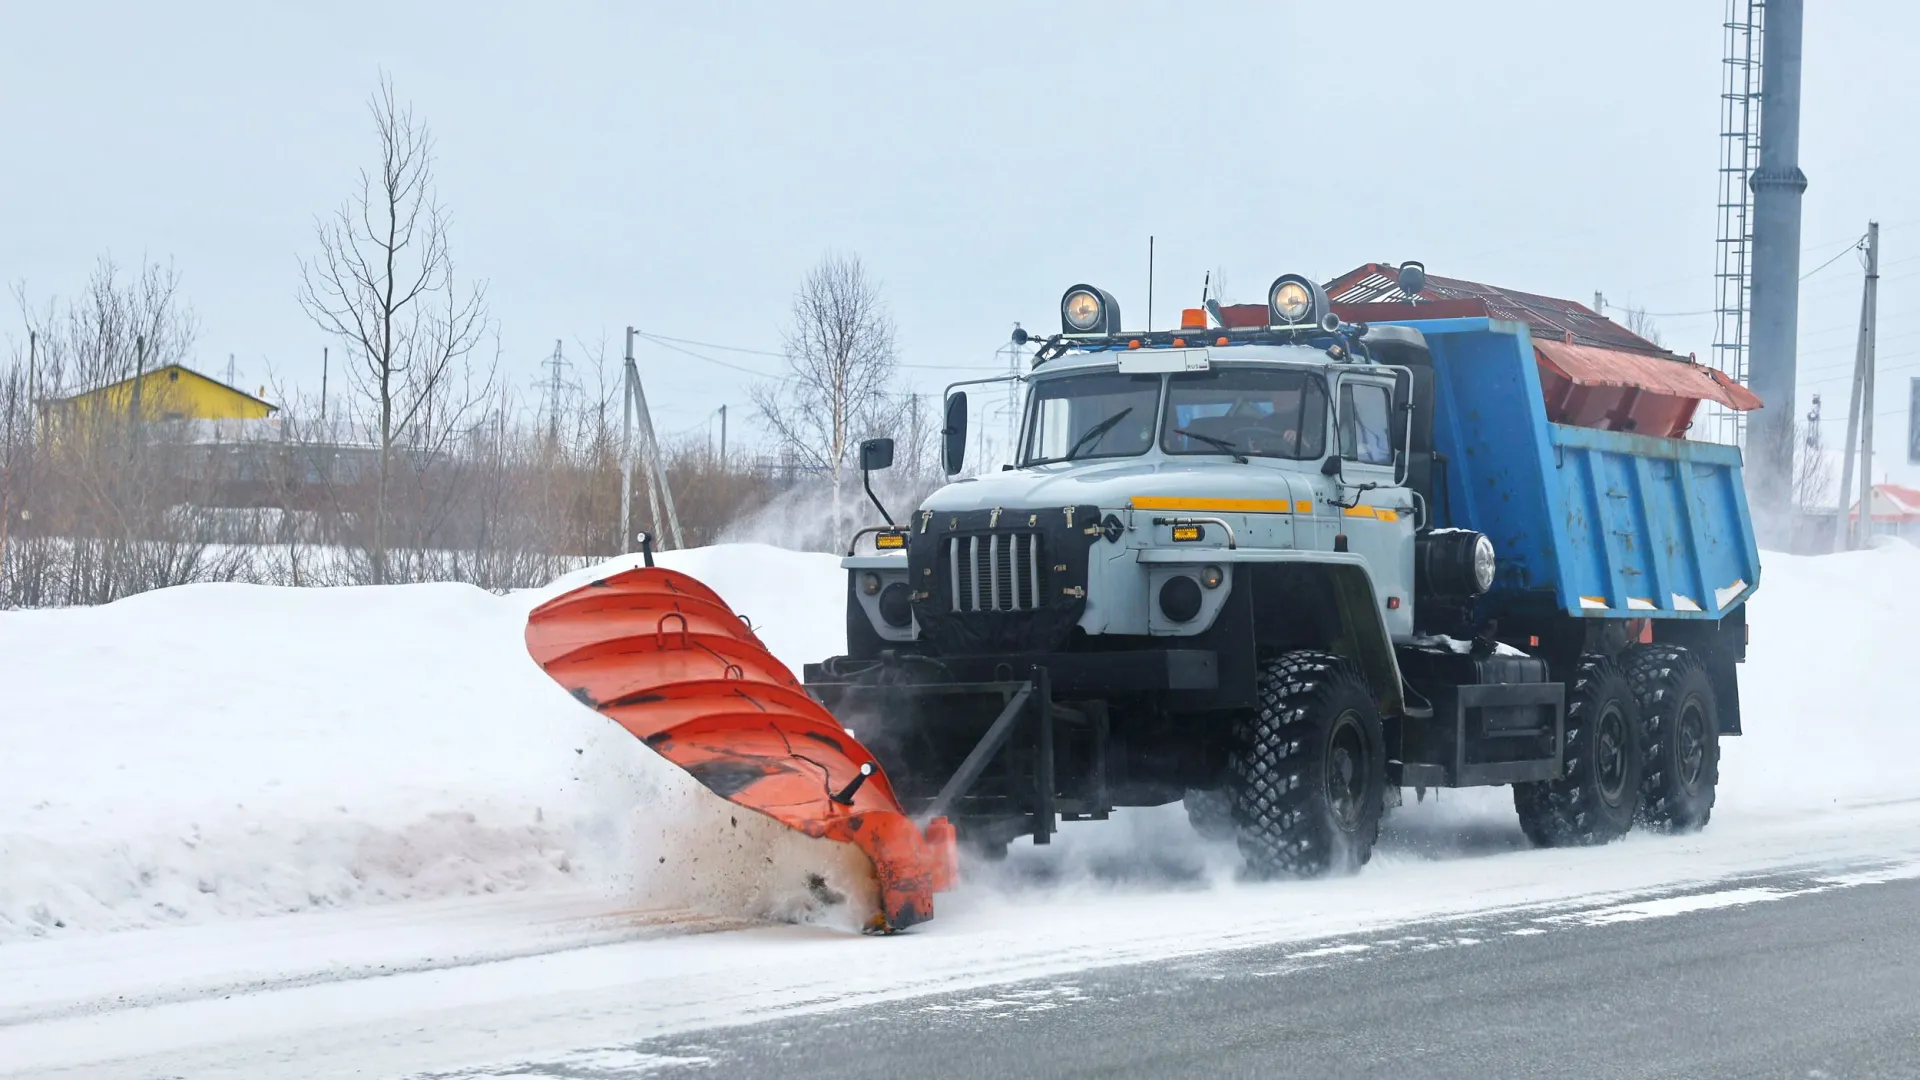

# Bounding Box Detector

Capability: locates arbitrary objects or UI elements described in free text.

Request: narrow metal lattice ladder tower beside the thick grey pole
[1705,0,1766,444]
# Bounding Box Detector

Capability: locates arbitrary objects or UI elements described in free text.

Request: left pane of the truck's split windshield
[1020,371,1160,465]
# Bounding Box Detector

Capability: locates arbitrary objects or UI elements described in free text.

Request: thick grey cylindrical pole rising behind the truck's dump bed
[1747,0,1807,526]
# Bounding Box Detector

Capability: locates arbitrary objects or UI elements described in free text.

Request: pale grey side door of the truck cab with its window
[1334,373,1413,638]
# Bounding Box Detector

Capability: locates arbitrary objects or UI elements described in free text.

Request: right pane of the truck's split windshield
[1160,367,1327,459]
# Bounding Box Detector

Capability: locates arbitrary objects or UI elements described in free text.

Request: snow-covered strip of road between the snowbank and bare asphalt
[0,801,1920,1078]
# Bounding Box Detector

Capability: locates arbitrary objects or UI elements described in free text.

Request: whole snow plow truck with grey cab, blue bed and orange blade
[528,263,1761,928]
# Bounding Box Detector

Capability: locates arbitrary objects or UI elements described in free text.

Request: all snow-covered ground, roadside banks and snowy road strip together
[0,546,1920,1076]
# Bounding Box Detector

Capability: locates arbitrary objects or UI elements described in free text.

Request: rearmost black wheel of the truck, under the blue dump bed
[1626,646,1720,832]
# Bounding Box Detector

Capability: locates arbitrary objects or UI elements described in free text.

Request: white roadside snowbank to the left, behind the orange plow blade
[0,546,860,942]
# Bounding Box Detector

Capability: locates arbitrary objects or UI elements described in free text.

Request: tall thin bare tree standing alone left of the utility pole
[300,75,497,584]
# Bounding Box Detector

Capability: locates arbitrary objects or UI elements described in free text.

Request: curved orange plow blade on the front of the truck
[526,567,956,930]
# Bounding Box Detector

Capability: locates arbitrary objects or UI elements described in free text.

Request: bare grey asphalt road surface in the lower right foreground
[602,874,1920,1080]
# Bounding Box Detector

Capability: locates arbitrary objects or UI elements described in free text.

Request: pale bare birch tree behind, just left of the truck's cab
[751,256,895,478]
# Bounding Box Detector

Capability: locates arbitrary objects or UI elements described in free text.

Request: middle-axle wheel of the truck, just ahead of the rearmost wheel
[1513,653,1644,847]
